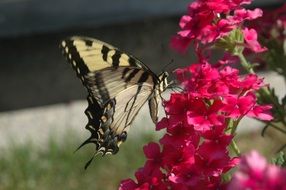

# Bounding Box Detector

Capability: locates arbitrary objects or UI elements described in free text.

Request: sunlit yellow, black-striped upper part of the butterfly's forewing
[61,37,146,75]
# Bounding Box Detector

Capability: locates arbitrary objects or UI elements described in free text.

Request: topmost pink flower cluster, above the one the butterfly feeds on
[171,0,266,53]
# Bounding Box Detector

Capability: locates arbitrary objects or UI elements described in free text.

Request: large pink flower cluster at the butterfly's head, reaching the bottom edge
[120,62,272,190]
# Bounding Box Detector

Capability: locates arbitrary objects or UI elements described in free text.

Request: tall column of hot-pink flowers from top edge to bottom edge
[119,0,278,190]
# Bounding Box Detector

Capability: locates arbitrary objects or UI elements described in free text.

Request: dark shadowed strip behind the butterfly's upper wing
[0,18,196,111]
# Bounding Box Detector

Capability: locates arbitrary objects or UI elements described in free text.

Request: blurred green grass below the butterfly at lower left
[0,134,158,190]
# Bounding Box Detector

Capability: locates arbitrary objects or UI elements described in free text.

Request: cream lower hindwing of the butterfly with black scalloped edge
[81,84,153,154]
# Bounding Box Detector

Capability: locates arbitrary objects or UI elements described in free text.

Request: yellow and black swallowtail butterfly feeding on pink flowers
[60,36,168,167]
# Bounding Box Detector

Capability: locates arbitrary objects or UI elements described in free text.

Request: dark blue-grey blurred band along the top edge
[0,0,283,37]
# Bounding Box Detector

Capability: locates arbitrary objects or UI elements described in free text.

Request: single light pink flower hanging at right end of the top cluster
[243,28,267,53]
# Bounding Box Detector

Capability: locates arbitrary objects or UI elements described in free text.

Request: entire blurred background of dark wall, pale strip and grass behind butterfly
[0,0,286,190]
